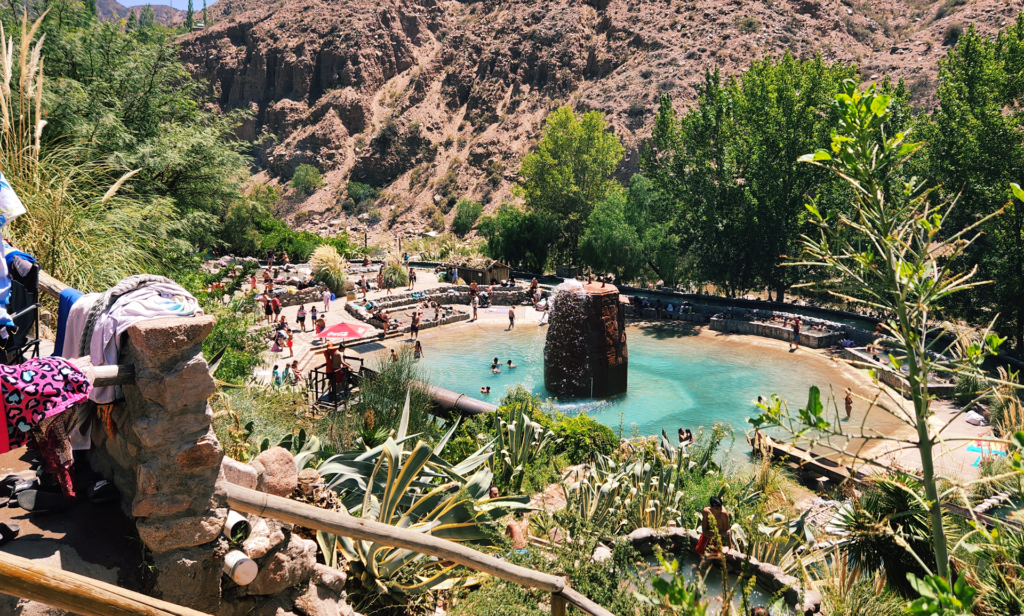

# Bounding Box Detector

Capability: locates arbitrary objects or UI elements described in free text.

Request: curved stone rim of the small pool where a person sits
[626,527,822,616]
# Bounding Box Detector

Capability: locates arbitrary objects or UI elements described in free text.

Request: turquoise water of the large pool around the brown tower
[407,322,846,444]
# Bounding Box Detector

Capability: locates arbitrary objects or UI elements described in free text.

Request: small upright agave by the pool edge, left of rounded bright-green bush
[489,403,555,492]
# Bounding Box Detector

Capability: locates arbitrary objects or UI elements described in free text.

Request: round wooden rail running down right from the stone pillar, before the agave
[224,485,614,616]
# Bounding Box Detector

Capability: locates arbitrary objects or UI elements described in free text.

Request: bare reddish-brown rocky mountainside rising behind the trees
[181,0,1020,243]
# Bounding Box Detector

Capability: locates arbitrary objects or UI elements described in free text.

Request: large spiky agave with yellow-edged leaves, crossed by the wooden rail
[322,439,530,596]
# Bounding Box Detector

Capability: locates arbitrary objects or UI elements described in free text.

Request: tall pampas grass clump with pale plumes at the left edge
[0,13,174,292]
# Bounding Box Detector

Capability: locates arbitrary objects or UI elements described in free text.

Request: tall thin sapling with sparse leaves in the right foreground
[751,80,1007,589]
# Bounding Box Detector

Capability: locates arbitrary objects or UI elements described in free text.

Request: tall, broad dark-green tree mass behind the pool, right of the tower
[641,53,855,298]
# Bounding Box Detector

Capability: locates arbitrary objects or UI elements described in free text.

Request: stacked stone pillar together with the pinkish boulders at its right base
[90,316,362,616]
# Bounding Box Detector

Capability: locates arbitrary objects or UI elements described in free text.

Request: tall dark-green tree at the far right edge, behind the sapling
[919,13,1024,354]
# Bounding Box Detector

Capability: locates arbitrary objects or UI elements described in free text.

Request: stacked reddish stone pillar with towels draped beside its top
[92,316,227,613]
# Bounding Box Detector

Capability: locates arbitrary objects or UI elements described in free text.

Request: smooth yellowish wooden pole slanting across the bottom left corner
[0,552,207,616]
